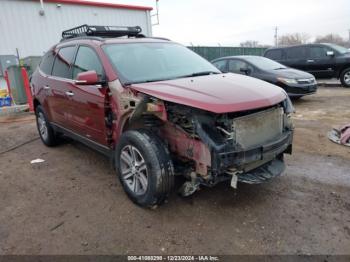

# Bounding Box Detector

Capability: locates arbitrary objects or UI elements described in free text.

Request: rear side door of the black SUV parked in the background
[284,46,307,71]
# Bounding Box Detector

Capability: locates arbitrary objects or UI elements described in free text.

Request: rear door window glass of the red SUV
[52,46,75,79]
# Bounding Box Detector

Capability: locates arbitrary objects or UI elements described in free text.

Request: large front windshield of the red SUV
[103,42,221,84]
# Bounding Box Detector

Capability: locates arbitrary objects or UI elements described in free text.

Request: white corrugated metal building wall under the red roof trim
[0,0,152,57]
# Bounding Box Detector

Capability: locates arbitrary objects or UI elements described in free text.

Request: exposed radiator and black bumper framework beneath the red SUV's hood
[163,101,293,184]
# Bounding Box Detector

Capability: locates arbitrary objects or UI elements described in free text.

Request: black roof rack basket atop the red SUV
[62,25,145,39]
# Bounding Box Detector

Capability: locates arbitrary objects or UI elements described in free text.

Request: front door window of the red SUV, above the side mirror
[73,46,103,79]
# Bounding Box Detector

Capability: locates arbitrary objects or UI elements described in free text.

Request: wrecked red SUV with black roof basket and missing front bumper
[31,25,293,207]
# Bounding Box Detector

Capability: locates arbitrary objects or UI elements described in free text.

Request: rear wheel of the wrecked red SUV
[35,106,58,147]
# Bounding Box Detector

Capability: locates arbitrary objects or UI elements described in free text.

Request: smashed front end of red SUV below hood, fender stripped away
[111,80,294,195]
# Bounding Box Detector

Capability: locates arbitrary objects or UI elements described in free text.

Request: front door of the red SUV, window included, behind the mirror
[68,45,107,145]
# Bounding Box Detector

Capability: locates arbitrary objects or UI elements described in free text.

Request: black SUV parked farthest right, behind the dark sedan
[264,44,350,87]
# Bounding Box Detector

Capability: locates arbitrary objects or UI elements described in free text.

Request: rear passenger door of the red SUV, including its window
[44,45,76,128]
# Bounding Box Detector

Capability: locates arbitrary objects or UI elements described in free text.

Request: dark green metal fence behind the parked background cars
[188,46,266,61]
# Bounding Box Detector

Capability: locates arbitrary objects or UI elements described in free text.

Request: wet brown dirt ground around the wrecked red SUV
[0,87,350,255]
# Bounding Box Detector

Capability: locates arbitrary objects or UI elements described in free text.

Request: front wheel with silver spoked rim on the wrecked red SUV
[115,130,174,208]
